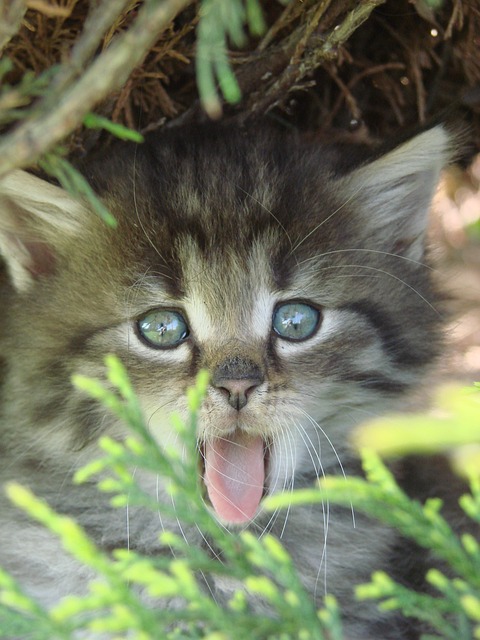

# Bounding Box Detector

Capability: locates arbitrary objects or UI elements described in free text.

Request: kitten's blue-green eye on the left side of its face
[137,309,188,349]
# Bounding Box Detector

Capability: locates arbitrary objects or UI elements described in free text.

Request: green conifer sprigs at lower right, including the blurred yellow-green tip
[265,383,480,640]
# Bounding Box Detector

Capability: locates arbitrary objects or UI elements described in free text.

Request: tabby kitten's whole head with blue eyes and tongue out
[0,127,448,523]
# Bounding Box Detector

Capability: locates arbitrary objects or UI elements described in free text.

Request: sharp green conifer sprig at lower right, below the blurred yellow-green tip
[265,451,480,640]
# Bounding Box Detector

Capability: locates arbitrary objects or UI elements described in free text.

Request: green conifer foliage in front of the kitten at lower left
[0,357,342,640]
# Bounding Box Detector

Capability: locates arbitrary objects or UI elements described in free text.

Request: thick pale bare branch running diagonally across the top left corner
[0,0,192,176]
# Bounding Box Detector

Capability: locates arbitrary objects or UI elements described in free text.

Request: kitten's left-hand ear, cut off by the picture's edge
[0,171,86,291]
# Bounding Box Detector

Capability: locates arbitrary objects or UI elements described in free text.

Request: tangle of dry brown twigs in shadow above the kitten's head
[0,0,480,153]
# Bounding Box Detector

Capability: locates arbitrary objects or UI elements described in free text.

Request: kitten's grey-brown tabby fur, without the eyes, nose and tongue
[0,125,466,640]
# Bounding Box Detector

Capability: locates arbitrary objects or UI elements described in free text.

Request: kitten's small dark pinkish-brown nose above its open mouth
[212,356,264,411]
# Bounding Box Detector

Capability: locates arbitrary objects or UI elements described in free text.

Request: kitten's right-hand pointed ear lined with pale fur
[342,125,458,260]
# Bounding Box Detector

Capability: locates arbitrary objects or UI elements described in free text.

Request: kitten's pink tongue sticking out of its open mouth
[205,431,265,523]
